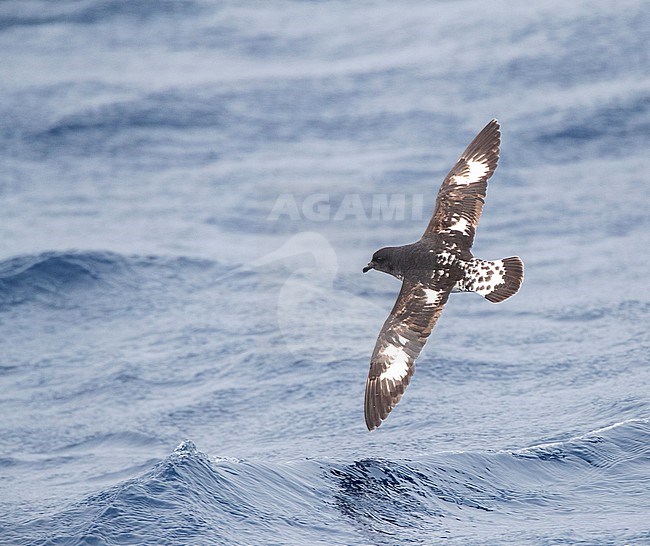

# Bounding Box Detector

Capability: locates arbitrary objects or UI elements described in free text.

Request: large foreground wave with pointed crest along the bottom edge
[11,419,650,544]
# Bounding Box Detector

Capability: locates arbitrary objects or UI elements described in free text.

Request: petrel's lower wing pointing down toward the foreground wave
[364,280,452,430]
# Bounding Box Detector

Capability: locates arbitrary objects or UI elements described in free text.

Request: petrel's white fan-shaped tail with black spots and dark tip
[456,256,524,303]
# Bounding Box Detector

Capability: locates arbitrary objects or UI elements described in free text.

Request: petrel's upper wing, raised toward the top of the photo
[422,119,501,250]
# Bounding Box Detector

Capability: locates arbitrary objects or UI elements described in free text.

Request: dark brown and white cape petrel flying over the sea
[363,119,524,430]
